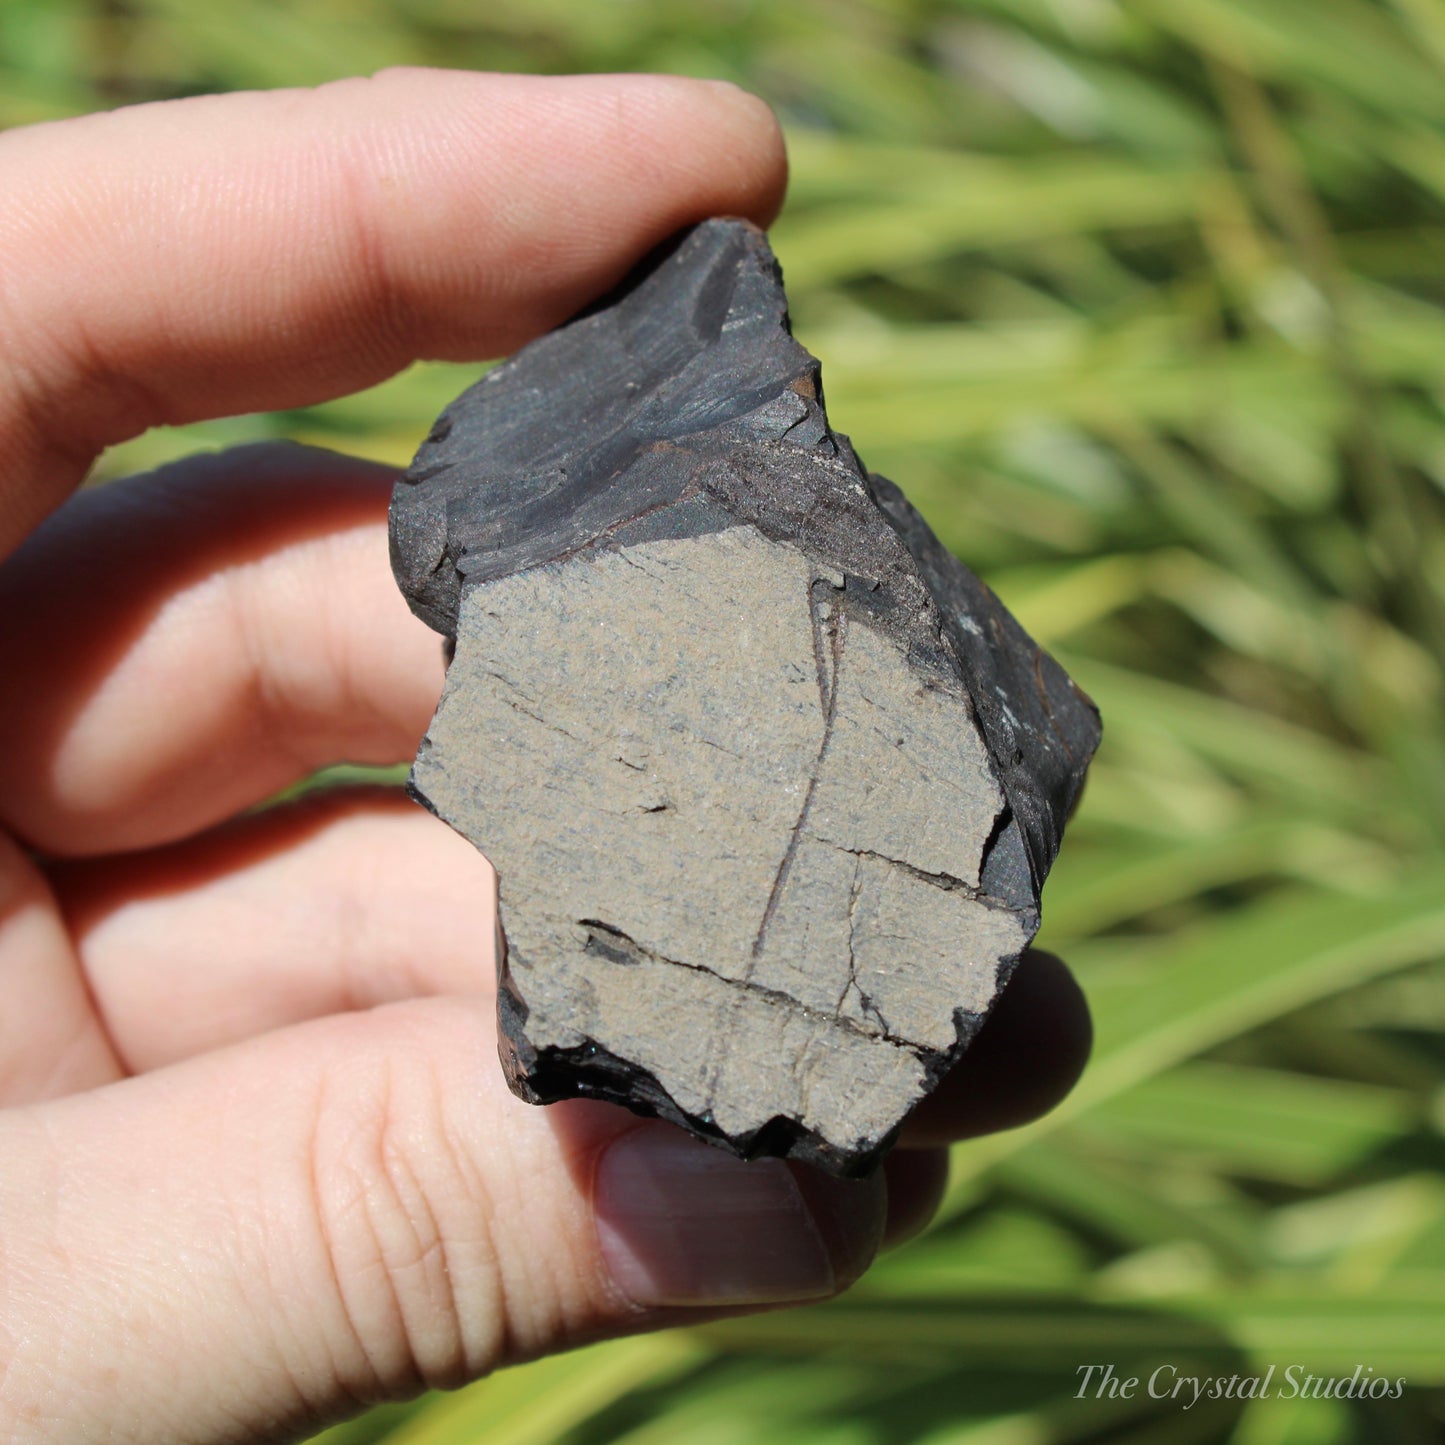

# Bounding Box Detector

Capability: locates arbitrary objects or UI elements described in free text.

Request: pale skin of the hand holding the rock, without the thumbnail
[0,71,1088,1445]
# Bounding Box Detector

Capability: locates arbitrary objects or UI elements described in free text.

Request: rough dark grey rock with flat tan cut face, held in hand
[392,221,1100,1175]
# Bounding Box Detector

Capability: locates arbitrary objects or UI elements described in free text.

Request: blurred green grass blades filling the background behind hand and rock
[0,0,1445,1445]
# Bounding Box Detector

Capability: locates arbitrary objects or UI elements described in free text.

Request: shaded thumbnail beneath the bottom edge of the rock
[594,1123,886,1306]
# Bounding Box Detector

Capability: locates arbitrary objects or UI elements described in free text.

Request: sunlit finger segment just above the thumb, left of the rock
[51,789,496,1074]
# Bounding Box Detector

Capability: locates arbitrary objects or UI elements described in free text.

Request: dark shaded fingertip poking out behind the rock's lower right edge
[902,948,1094,1147]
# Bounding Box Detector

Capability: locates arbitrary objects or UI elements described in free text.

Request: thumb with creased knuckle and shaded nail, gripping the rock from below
[0,998,886,1442]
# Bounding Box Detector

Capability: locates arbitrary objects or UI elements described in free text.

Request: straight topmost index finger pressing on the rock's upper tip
[0,69,785,556]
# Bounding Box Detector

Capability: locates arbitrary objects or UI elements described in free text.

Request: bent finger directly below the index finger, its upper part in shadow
[0,445,442,855]
